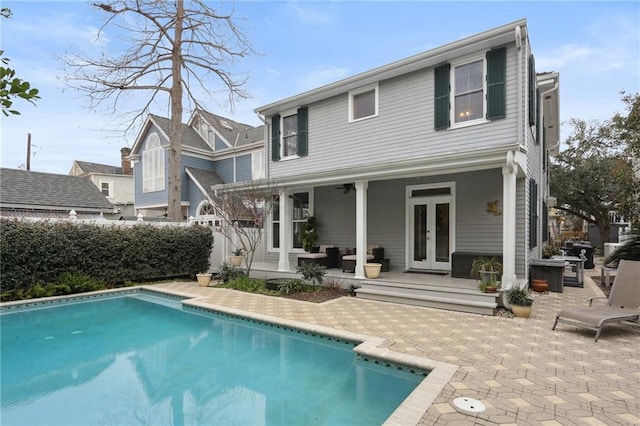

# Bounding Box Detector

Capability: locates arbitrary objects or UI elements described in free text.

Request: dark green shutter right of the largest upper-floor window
[487,47,507,120]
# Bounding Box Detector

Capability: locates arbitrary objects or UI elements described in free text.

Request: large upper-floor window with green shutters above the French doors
[434,47,507,130]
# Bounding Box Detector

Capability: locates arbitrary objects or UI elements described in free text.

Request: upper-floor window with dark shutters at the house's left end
[271,107,309,161]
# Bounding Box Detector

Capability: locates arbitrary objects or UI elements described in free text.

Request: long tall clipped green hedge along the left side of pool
[0,219,213,292]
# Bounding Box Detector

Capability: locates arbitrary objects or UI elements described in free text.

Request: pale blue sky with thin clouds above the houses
[0,0,640,174]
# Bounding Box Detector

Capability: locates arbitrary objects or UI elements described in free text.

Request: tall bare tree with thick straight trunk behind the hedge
[63,0,253,220]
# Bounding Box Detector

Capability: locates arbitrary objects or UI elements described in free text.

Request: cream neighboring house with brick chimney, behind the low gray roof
[69,147,136,219]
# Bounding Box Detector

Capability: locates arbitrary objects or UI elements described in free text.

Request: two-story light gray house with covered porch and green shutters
[255,19,560,294]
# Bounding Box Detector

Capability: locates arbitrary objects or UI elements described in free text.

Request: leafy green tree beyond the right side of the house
[550,95,640,242]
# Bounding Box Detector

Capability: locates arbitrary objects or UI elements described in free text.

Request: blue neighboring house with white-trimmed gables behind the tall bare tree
[130,110,265,220]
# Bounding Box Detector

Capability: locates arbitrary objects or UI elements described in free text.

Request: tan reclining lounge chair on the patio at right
[551,260,640,342]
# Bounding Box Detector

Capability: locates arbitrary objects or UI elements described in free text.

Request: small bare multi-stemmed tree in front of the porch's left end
[209,181,278,275]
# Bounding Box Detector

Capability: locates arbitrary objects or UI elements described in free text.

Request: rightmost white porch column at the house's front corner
[502,152,518,290]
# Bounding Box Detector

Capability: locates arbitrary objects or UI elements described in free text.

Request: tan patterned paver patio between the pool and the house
[156,269,640,425]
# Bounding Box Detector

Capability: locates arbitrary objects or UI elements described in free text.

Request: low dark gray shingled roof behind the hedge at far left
[0,168,113,212]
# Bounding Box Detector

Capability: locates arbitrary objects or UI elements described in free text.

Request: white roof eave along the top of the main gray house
[254,19,527,117]
